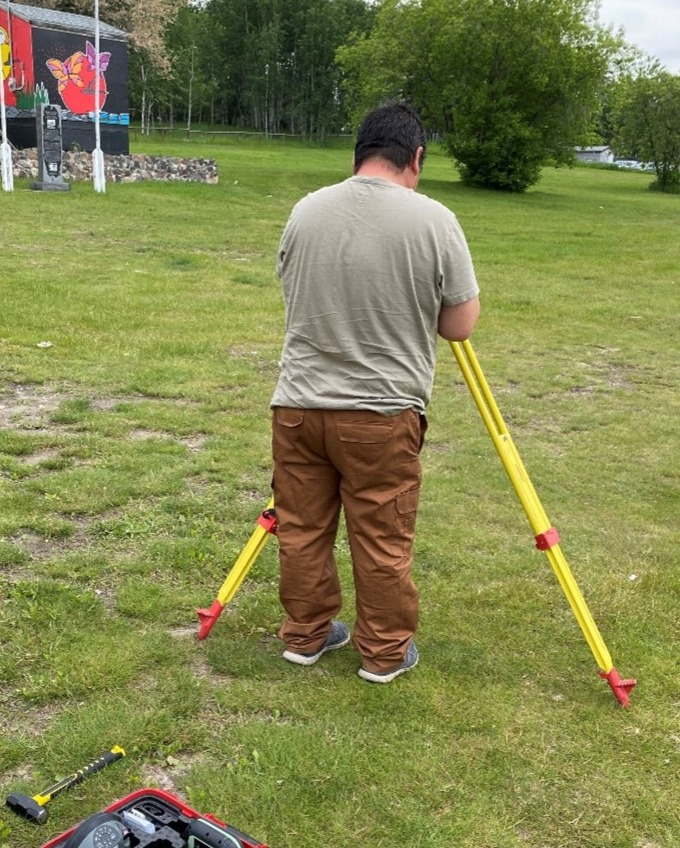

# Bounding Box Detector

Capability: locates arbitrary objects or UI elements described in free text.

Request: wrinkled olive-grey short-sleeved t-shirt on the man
[271,177,479,415]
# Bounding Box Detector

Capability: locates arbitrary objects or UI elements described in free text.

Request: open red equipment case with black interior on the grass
[42,789,267,848]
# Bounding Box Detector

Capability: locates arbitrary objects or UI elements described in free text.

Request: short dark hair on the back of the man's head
[354,103,427,171]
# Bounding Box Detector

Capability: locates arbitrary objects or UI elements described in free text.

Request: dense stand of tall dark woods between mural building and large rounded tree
[130,0,374,139]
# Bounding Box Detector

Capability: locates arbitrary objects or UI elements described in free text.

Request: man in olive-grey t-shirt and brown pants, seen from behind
[271,103,479,683]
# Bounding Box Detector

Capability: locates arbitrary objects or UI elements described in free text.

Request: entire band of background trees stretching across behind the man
[29,0,680,192]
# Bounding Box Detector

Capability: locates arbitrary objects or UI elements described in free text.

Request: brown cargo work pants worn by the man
[272,407,426,672]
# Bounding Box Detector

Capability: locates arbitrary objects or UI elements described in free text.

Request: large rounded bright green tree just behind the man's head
[338,0,619,192]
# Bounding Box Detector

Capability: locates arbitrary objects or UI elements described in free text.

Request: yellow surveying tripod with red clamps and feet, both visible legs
[196,341,636,707]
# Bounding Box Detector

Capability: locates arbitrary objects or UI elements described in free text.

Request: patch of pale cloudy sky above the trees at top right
[599,0,680,74]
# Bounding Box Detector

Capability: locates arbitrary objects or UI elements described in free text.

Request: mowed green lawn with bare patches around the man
[0,140,680,848]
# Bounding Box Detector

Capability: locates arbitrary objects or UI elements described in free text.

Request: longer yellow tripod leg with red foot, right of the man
[450,341,635,706]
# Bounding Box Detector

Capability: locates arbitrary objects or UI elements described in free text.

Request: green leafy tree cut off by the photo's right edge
[616,69,680,193]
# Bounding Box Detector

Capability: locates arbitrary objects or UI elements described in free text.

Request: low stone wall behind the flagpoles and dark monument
[12,149,217,185]
